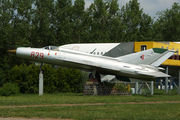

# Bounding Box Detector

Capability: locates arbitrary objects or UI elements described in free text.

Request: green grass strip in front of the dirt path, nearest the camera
[0,104,180,120]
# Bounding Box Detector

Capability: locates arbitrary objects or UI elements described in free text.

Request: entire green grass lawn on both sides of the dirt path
[0,93,180,120]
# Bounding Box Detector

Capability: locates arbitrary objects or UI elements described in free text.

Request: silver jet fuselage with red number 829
[16,48,169,80]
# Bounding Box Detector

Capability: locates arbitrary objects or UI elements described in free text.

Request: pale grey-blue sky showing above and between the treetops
[72,0,180,19]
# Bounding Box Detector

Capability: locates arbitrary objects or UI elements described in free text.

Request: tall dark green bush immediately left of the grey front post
[11,64,39,93]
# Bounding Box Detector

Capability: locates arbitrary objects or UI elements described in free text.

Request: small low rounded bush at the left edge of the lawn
[0,82,19,96]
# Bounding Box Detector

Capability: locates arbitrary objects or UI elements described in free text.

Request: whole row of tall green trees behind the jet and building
[0,0,180,94]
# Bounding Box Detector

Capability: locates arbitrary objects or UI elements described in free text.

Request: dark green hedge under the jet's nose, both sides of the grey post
[11,64,87,93]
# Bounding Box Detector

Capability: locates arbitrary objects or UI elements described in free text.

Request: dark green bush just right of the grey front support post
[48,67,86,93]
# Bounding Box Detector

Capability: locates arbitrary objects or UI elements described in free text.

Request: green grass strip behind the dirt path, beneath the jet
[0,93,180,106]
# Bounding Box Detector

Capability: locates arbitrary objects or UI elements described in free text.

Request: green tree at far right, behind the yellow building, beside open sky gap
[153,3,180,41]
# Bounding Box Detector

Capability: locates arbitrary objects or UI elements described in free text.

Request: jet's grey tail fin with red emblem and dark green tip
[117,48,176,66]
